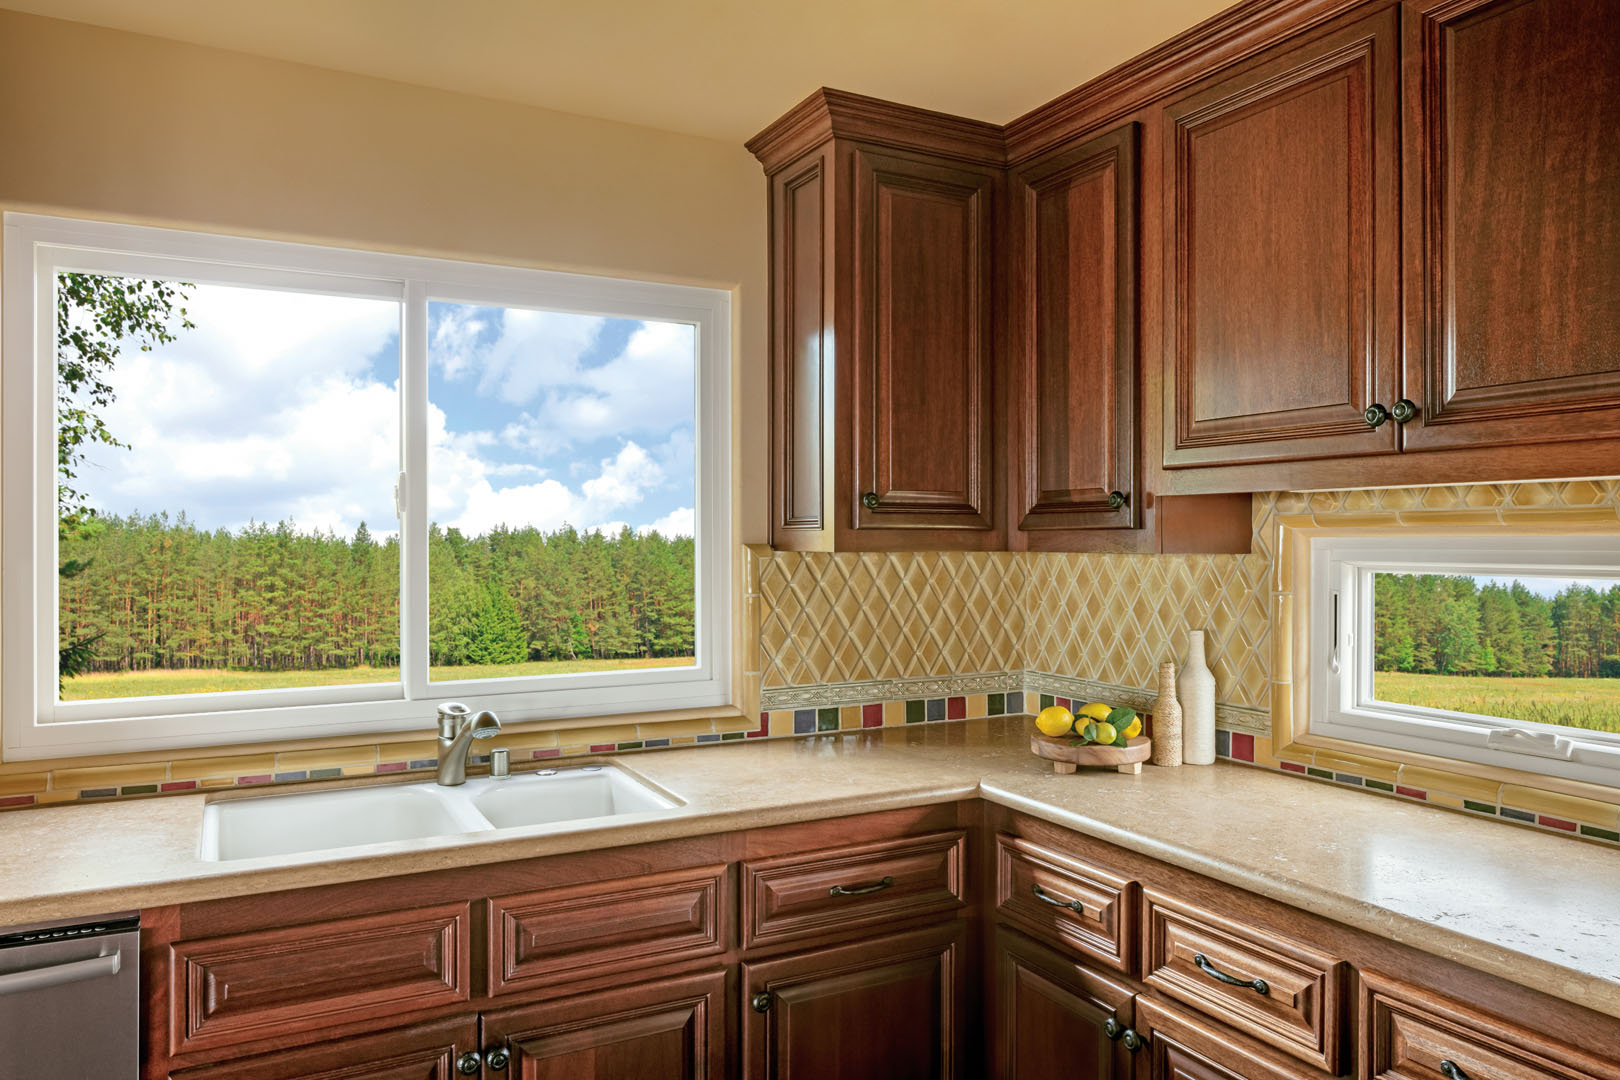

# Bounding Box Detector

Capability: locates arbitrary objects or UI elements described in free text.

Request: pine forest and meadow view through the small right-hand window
[1374,573,1620,732]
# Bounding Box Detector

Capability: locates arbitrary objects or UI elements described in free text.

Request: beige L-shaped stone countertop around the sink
[0,717,1620,1017]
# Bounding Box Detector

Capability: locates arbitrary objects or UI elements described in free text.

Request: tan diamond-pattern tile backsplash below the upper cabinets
[760,479,1620,709]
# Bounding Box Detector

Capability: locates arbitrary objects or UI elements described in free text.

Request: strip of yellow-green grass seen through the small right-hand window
[1374,672,1620,732]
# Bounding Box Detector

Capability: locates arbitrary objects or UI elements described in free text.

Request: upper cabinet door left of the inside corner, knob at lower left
[839,146,998,544]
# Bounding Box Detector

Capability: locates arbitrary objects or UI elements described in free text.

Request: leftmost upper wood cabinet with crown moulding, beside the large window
[748,91,1006,551]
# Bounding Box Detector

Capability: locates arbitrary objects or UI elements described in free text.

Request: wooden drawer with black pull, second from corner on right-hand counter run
[1144,889,1348,1074]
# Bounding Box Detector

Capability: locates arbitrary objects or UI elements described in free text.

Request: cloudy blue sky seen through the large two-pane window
[72,285,695,534]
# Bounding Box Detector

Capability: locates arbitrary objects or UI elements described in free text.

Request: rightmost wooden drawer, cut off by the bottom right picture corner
[1358,972,1620,1080]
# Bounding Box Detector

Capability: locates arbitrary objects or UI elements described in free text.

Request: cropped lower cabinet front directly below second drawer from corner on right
[1136,997,1324,1080]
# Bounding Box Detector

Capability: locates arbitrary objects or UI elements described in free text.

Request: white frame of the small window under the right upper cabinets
[1309,534,1620,787]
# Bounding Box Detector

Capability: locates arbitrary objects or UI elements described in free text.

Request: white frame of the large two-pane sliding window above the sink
[0,214,732,761]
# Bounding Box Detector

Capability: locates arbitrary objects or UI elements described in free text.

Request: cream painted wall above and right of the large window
[0,10,768,542]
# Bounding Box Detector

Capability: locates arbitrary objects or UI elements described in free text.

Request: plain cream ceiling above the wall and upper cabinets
[0,0,1230,142]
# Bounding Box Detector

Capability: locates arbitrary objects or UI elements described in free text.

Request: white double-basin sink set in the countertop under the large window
[201,766,679,861]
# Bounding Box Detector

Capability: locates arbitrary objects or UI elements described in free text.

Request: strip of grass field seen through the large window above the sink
[62,656,692,701]
